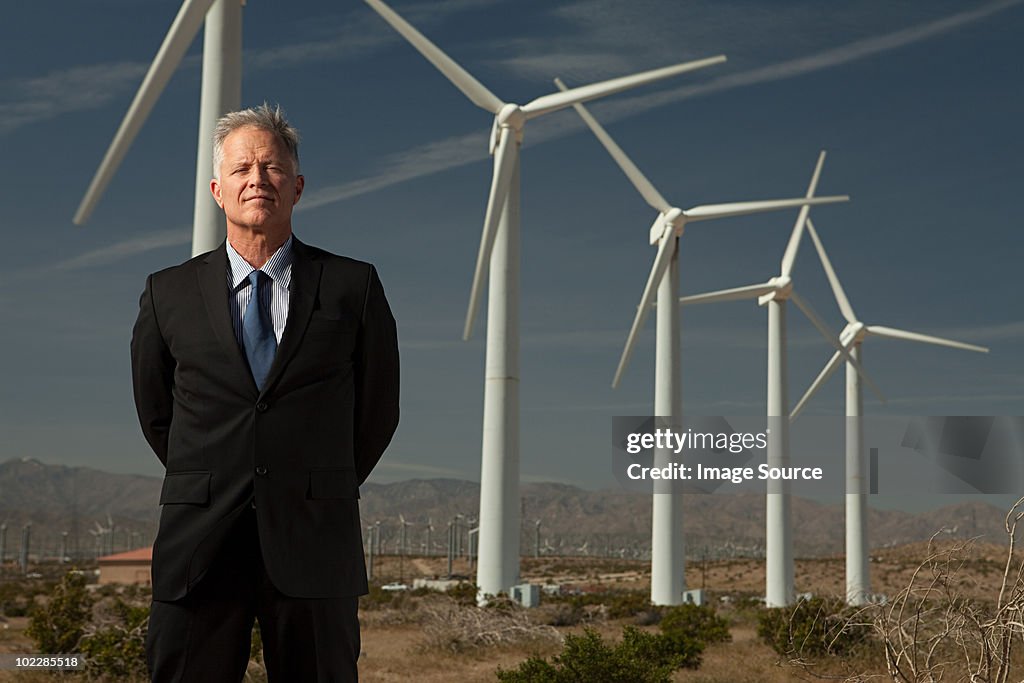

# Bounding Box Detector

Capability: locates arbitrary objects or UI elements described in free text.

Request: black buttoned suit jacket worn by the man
[131,240,398,600]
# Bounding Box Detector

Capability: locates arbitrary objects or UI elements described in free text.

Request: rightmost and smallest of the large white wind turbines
[791,219,988,605]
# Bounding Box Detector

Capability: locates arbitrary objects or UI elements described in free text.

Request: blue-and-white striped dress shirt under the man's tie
[226,237,292,346]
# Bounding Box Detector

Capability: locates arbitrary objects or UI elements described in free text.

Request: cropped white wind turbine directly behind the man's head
[74,0,244,256]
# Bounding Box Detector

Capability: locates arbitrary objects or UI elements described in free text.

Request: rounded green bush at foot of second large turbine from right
[758,598,869,656]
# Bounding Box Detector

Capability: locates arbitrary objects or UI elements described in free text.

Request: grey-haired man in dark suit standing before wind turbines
[131,104,398,683]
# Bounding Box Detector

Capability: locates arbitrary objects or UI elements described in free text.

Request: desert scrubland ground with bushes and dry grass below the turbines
[0,502,1024,683]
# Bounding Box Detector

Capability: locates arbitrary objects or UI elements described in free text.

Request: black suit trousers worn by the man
[145,509,359,683]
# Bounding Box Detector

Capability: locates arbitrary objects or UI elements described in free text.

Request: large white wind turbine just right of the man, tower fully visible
[366,0,725,600]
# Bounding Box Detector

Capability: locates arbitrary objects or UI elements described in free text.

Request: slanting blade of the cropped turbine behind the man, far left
[72,0,214,225]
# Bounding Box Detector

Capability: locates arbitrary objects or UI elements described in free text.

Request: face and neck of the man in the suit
[210,127,303,236]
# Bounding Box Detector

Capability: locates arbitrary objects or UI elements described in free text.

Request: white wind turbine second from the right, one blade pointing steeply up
[679,152,874,607]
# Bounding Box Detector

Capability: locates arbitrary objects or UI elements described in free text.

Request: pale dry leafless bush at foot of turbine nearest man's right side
[420,598,562,653]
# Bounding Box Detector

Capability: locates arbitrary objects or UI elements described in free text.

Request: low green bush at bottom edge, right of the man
[498,626,700,683]
